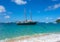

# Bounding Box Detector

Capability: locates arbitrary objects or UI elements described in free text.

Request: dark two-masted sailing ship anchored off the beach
[17,10,37,25]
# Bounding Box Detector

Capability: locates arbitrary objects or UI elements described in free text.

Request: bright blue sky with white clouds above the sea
[0,0,60,22]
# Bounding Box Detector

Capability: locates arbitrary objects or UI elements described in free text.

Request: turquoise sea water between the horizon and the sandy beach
[0,23,60,39]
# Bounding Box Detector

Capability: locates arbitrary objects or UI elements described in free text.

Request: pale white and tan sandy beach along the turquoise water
[0,34,60,42]
